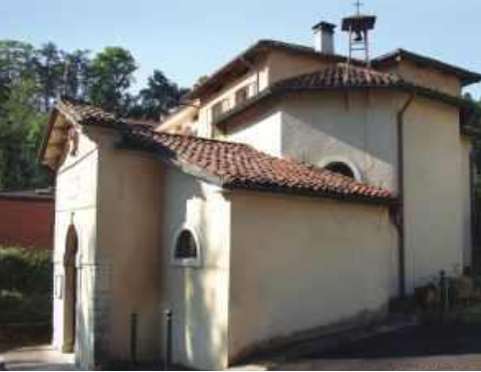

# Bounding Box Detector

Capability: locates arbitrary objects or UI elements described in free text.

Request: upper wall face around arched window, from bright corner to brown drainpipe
[282,92,397,190]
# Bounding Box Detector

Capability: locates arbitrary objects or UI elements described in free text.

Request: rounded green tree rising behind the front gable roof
[89,48,137,115]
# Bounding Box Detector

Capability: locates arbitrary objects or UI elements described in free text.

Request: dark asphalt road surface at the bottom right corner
[274,327,481,371]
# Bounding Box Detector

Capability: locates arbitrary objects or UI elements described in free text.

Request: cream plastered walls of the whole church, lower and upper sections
[47,36,472,370]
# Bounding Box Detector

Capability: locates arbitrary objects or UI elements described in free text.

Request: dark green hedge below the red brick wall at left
[0,248,52,325]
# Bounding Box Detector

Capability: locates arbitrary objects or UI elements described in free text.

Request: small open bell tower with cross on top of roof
[342,0,377,67]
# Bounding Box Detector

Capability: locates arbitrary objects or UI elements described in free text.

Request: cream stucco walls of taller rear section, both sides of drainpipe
[223,91,472,295]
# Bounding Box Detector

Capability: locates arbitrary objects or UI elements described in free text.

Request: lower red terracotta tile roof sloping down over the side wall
[127,128,392,202]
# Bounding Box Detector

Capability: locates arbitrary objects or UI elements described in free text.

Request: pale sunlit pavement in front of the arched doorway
[0,346,75,371]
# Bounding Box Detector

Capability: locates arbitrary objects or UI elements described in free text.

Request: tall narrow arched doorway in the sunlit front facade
[62,225,79,353]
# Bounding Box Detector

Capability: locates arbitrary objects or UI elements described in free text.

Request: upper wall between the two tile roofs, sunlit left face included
[225,92,404,190]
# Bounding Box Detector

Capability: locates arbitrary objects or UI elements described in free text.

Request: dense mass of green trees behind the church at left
[0,40,186,190]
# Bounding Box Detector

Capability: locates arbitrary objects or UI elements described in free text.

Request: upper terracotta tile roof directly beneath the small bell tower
[273,63,407,90]
